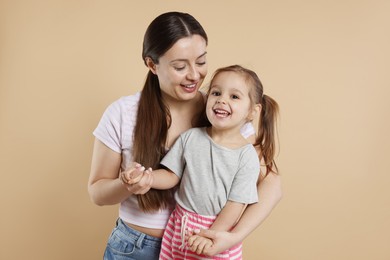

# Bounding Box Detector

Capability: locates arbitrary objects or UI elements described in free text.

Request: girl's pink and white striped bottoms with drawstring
[160,204,242,260]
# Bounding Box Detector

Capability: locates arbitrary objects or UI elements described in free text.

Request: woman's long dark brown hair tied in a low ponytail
[132,12,207,212]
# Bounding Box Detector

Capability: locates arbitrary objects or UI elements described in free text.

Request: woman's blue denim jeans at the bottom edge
[103,218,162,260]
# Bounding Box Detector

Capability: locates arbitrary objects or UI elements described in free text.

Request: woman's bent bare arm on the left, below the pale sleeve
[88,138,152,206]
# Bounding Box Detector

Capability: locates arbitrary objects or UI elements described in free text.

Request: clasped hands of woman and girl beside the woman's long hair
[119,163,153,194]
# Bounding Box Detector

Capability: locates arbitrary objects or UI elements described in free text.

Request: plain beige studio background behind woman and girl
[0,0,390,260]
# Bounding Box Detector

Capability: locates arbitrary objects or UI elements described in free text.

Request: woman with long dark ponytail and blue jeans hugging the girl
[88,12,280,259]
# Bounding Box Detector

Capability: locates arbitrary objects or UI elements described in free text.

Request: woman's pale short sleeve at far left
[93,99,122,153]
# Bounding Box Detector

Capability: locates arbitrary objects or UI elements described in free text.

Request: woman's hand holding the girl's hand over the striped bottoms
[188,229,240,256]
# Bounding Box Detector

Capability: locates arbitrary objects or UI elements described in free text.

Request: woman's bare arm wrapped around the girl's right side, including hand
[190,173,282,256]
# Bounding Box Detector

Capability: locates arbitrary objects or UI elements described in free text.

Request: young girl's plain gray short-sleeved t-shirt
[161,128,260,216]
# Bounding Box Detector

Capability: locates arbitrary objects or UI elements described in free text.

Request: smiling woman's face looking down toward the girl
[149,35,207,101]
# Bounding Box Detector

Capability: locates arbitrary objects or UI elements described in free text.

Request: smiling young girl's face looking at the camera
[206,71,255,130]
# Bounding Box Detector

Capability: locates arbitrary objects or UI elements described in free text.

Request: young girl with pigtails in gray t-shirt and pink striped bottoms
[128,65,277,259]
